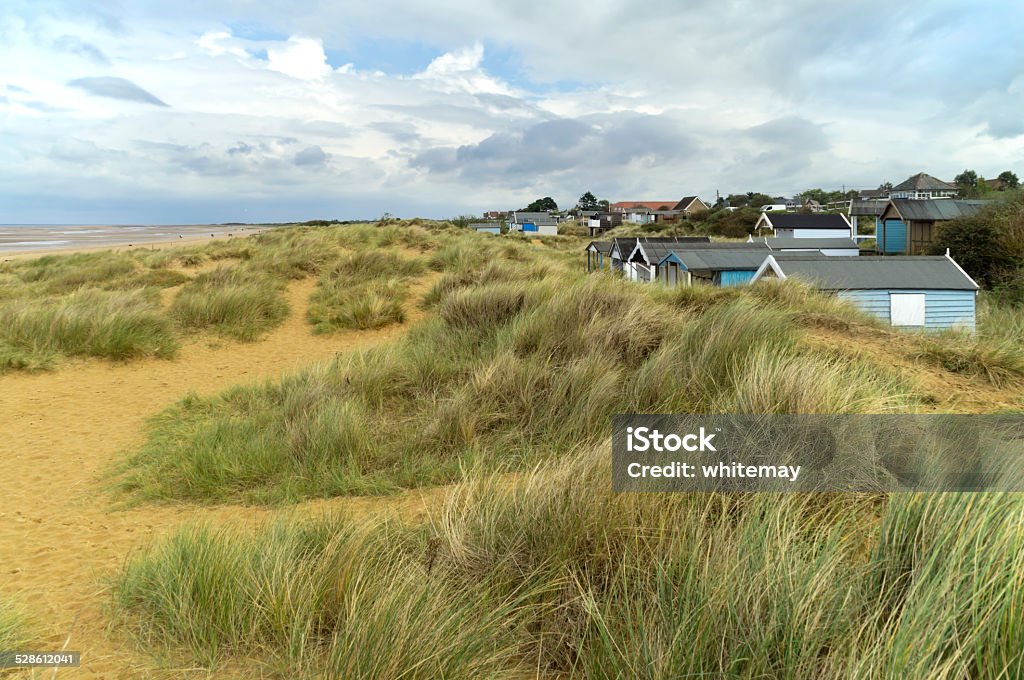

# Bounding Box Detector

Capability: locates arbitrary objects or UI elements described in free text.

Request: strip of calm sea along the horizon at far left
[0,224,260,253]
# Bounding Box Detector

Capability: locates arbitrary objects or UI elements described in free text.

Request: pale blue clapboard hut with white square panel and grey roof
[752,252,978,333]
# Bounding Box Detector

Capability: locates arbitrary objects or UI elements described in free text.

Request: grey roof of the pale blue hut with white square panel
[771,253,978,291]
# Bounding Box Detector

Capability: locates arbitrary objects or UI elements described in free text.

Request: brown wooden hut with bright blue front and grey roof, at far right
[876,199,990,255]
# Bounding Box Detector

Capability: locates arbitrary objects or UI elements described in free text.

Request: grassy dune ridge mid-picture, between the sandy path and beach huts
[116,263,912,502]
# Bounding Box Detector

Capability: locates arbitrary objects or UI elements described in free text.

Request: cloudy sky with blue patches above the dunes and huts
[0,0,1024,223]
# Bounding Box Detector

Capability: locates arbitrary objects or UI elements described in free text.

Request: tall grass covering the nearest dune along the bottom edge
[118,449,1024,679]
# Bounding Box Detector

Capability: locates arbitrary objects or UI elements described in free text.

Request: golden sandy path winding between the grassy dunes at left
[0,281,436,678]
